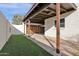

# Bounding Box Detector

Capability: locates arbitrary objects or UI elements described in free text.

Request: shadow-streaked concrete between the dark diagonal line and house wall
[47,37,79,56]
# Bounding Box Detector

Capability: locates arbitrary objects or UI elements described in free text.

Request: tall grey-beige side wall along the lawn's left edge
[0,12,11,50]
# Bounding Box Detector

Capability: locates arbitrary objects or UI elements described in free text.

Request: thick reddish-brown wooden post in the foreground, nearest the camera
[56,3,60,54]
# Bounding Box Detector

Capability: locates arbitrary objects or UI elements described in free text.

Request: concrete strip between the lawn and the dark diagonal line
[28,34,60,55]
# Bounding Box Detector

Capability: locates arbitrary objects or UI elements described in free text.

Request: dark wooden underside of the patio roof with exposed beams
[23,3,76,24]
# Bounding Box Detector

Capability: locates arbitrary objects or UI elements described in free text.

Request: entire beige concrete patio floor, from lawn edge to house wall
[25,34,79,56]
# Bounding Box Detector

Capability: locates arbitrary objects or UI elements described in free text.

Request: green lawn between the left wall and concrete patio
[0,35,51,56]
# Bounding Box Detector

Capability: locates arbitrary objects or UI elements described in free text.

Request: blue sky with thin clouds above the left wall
[0,3,33,22]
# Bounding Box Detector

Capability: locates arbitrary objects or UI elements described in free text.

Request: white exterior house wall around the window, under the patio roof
[45,8,79,38]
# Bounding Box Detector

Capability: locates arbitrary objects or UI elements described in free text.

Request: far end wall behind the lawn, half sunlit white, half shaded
[12,24,24,35]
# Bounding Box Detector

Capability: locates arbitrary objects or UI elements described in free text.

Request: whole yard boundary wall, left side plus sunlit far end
[0,12,24,50]
